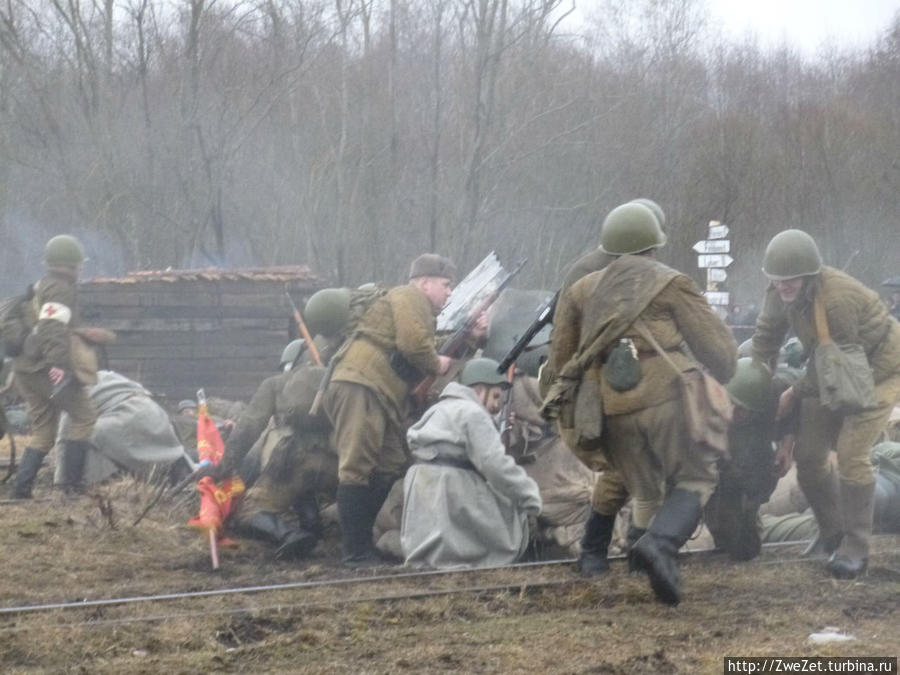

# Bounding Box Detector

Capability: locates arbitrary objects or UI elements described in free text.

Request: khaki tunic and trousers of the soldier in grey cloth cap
[324,285,440,485]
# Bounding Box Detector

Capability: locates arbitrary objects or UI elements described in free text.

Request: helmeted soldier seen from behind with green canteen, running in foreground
[550,203,736,604]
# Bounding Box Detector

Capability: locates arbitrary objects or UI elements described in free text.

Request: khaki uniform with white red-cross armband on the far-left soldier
[13,272,97,452]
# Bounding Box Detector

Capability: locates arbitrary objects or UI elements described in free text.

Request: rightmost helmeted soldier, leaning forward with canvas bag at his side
[753,230,900,579]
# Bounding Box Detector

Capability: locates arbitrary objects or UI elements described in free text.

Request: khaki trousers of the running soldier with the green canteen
[603,399,720,529]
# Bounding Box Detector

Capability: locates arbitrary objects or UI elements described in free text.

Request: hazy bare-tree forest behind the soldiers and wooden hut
[0,0,900,303]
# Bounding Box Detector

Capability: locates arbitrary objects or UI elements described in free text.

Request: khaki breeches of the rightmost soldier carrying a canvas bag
[794,375,900,485]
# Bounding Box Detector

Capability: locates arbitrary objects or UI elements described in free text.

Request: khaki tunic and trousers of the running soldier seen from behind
[551,256,737,528]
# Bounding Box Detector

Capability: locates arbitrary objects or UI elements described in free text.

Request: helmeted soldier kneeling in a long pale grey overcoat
[400,358,541,568]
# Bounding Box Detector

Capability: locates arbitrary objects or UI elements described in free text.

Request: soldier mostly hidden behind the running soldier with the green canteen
[554,198,666,577]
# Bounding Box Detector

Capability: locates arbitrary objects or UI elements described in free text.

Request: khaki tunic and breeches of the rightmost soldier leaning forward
[753,266,900,485]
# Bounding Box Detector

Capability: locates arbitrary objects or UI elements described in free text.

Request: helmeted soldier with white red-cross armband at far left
[13,234,97,499]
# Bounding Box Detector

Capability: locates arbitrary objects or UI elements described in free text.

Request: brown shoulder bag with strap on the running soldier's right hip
[634,319,734,455]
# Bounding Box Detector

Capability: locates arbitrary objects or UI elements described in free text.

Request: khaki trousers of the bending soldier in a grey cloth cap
[324,382,409,485]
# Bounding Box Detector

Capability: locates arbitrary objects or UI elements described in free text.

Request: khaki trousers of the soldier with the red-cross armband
[15,370,97,452]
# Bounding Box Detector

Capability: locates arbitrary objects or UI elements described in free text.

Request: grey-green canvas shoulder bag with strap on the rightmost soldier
[813,292,875,415]
